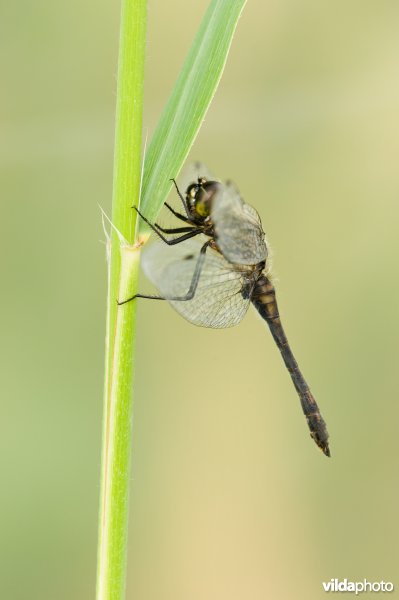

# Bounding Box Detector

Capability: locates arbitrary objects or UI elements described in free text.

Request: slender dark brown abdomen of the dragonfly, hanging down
[251,274,330,456]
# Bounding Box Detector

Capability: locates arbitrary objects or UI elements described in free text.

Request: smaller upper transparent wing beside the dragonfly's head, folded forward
[211,183,267,265]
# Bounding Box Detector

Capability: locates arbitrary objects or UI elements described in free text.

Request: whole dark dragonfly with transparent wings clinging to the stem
[118,163,330,456]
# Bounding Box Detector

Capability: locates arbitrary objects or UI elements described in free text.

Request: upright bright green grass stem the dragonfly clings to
[97,0,147,600]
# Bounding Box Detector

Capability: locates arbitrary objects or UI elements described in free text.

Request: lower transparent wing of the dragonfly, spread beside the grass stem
[143,235,250,328]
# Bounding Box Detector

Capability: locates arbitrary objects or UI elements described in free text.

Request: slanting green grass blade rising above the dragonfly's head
[140,0,246,229]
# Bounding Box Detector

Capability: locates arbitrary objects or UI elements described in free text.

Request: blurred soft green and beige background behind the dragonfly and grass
[0,0,399,600]
